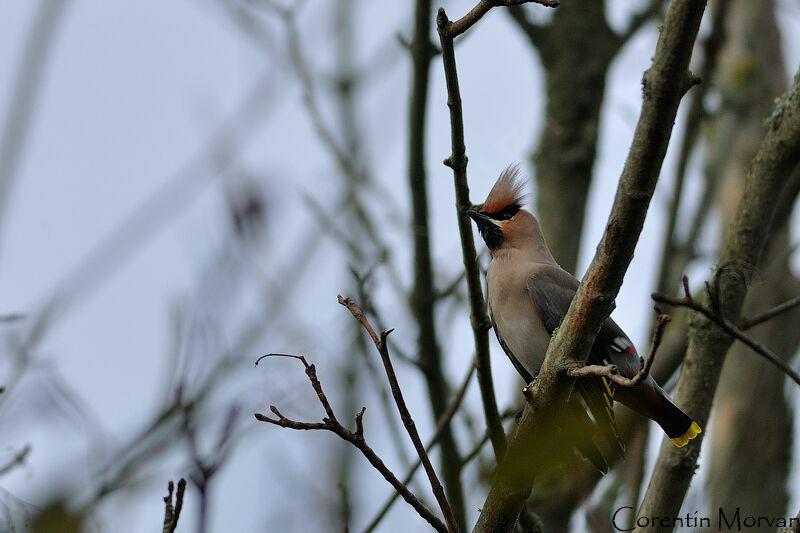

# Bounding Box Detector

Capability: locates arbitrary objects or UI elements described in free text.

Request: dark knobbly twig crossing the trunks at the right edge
[652,276,800,385]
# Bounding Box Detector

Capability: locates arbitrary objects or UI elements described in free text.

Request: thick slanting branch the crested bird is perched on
[475,0,705,532]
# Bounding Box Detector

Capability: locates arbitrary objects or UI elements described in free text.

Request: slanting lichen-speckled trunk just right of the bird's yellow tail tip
[639,66,800,532]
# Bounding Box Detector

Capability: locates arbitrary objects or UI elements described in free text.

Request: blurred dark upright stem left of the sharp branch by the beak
[408,0,466,529]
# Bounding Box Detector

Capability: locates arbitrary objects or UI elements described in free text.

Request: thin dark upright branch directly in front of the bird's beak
[436,8,506,463]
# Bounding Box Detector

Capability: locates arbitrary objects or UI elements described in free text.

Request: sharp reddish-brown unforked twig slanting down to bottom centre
[339,295,458,531]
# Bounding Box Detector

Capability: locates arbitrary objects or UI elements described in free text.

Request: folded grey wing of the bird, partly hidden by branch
[527,266,635,455]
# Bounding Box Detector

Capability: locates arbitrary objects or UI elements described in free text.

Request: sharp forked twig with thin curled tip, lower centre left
[255,354,450,533]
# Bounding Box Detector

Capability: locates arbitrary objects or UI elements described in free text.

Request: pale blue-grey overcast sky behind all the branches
[0,0,800,533]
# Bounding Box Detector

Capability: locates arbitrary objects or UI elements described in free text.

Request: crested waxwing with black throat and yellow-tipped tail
[467,165,701,472]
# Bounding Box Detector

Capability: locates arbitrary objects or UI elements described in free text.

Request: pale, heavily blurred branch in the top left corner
[0,0,70,243]
